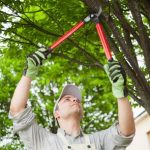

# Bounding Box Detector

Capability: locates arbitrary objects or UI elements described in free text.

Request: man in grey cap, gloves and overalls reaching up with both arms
[10,49,135,150]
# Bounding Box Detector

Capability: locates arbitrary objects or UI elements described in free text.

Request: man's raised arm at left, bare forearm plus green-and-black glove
[10,48,50,116]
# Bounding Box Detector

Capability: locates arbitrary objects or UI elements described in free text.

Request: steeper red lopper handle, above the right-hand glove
[96,23,113,61]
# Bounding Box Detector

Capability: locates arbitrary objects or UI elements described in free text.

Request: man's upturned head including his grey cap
[54,84,83,125]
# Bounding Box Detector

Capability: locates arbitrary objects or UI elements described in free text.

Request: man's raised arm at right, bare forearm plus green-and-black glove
[104,61,135,136]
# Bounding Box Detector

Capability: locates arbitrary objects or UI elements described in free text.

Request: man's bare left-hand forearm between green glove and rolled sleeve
[10,76,32,115]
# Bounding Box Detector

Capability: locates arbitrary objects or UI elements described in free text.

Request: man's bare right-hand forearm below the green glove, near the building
[118,97,135,136]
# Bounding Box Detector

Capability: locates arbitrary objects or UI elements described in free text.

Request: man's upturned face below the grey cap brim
[54,95,83,119]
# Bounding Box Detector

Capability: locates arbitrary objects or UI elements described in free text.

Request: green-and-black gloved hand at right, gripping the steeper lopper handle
[104,61,128,99]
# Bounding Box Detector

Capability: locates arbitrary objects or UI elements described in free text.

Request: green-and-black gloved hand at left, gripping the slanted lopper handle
[23,48,51,79]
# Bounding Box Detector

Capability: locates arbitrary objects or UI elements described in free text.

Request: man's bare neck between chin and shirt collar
[59,118,81,137]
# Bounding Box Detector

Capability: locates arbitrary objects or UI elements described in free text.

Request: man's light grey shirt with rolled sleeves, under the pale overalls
[10,107,134,150]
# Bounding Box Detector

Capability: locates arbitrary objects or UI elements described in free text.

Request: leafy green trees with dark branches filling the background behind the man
[0,0,150,150]
